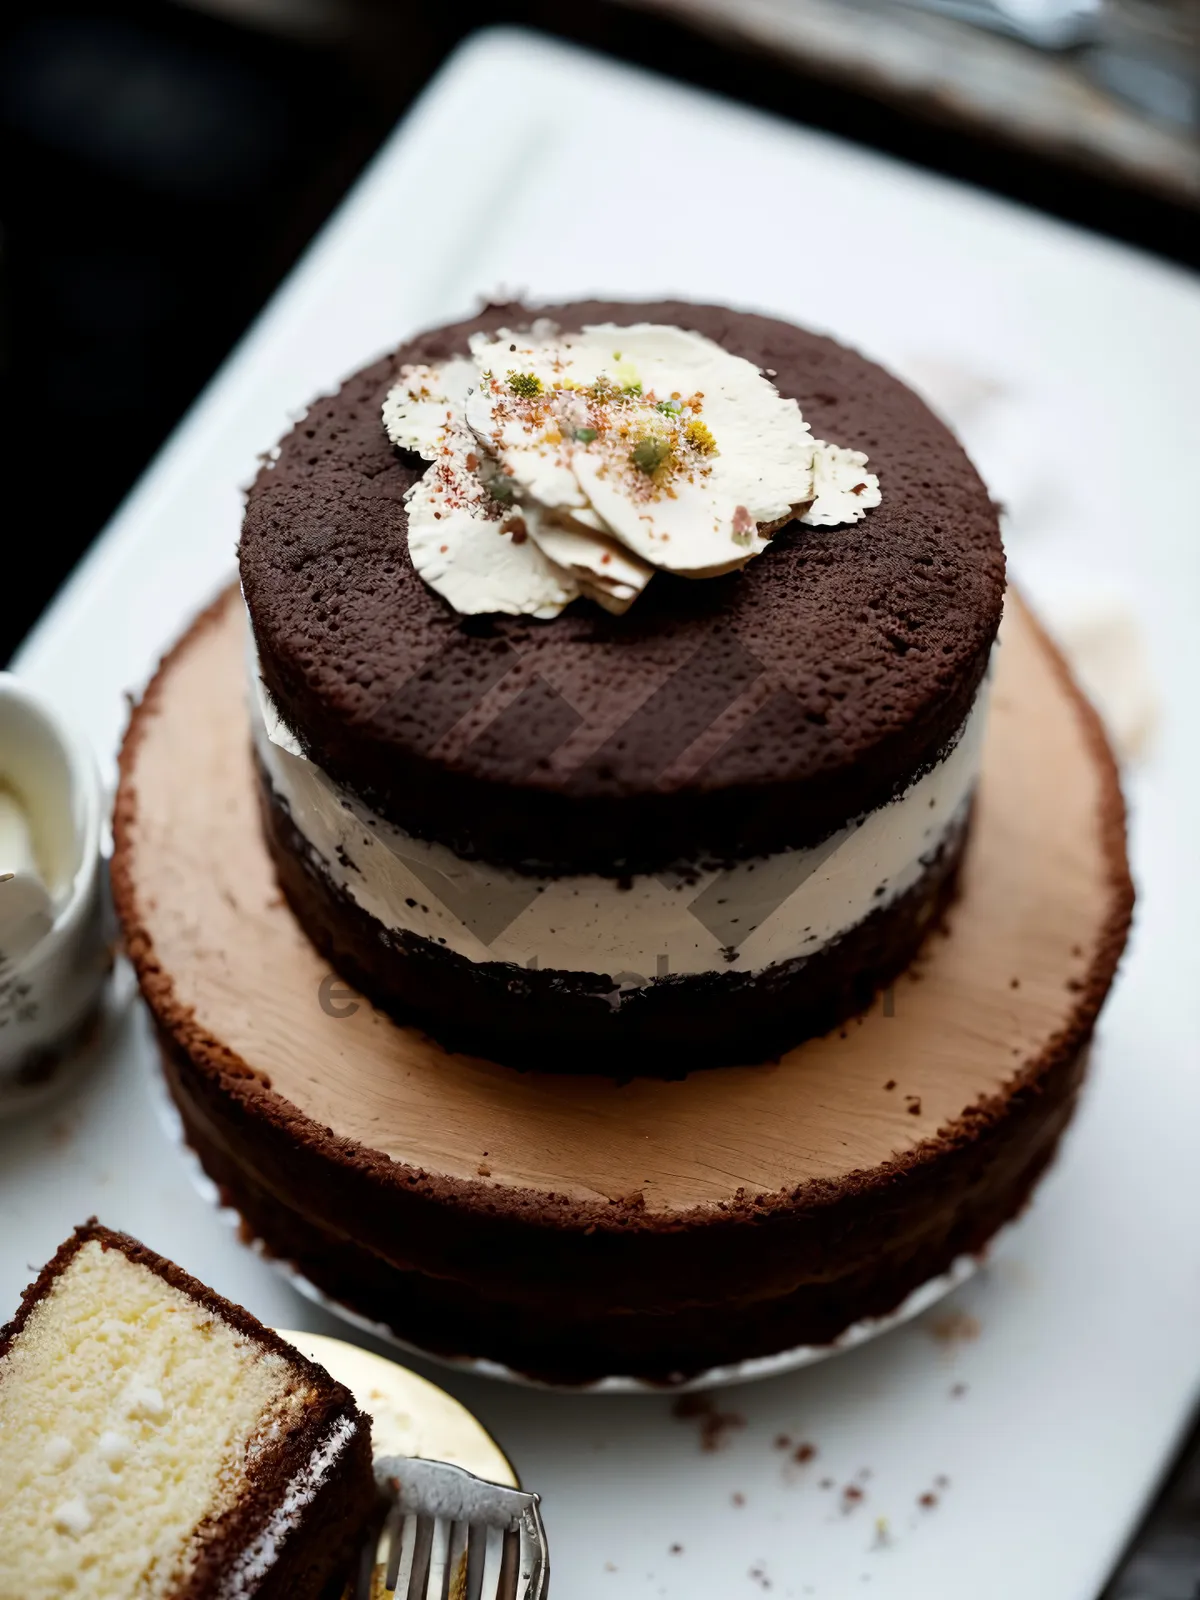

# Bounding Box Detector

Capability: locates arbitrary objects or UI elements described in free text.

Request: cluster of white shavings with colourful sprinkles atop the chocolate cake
[384,318,880,618]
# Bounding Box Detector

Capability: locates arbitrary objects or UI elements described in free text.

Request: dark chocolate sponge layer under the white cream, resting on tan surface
[259,766,968,1078]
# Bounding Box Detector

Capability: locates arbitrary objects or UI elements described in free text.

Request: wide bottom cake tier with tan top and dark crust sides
[114,594,1133,1381]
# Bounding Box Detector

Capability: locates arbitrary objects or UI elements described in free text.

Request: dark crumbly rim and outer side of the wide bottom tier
[112,579,1133,1378]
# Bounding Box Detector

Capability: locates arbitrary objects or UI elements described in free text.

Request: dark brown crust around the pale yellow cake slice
[0,1218,374,1600]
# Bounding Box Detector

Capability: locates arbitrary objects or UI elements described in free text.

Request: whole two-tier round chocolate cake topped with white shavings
[112,304,1131,1382]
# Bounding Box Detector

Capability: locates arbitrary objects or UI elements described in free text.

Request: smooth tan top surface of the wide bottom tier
[123,592,1128,1213]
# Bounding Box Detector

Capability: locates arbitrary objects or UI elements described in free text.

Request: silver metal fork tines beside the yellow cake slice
[354,1456,550,1600]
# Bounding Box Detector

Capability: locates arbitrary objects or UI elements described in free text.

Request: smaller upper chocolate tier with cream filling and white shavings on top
[240,302,1005,1074]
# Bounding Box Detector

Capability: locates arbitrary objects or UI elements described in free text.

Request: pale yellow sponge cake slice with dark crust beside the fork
[0,1221,374,1600]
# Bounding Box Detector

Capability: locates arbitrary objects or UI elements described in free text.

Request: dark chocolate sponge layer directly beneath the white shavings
[240,301,1005,877]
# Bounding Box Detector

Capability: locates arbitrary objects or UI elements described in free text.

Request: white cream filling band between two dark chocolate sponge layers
[251,649,987,990]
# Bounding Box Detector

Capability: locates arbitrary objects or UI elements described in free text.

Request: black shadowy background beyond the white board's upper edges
[0,0,1200,661]
